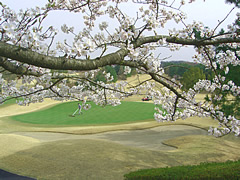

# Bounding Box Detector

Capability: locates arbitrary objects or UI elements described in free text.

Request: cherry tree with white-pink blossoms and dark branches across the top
[0,0,240,137]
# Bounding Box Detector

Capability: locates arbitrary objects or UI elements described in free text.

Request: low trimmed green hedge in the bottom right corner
[124,160,240,180]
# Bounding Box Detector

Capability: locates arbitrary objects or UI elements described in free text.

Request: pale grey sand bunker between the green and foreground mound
[16,125,207,150]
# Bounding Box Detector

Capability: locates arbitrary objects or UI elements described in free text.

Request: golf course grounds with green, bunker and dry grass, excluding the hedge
[0,76,240,180]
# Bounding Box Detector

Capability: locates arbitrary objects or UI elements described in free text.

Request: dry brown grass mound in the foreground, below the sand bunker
[0,136,240,180]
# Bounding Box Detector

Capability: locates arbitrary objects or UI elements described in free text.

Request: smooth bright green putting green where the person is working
[12,102,158,125]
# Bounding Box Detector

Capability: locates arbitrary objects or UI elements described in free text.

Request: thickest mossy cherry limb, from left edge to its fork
[0,42,138,71]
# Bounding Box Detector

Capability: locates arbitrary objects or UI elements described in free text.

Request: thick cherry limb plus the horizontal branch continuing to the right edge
[0,35,240,70]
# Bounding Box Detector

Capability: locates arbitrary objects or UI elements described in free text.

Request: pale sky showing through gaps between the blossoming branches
[1,0,240,61]
